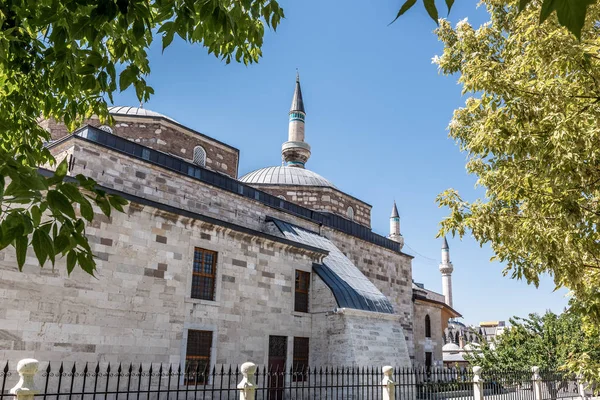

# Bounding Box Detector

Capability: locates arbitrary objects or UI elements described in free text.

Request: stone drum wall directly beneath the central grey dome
[252,184,371,228]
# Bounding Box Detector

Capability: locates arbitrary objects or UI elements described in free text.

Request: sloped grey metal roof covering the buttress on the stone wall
[270,218,394,314]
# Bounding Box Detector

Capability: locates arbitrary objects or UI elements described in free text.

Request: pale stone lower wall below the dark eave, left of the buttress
[0,199,331,364]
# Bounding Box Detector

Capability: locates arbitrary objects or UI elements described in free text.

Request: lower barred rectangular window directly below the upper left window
[184,329,212,385]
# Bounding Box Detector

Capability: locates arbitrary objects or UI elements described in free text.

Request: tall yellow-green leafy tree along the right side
[434,0,600,380]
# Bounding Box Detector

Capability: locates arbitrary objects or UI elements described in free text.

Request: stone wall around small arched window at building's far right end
[413,300,444,367]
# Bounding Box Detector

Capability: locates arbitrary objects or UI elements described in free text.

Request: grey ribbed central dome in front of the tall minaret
[240,166,335,188]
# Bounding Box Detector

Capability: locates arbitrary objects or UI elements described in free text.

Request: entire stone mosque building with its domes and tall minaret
[0,74,458,366]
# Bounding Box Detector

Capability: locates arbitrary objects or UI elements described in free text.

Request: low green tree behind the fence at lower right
[465,311,600,371]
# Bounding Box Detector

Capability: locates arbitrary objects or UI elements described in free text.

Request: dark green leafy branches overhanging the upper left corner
[0,0,283,274]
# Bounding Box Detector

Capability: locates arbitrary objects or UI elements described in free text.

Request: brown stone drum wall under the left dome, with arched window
[40,115,239,178]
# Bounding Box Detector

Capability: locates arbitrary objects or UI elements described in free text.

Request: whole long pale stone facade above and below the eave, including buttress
[0,132,413,366]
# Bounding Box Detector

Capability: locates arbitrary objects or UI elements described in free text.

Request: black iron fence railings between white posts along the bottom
[0,363,578,400]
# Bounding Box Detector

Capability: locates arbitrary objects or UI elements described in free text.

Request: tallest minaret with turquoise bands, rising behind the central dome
[281,72,310,168]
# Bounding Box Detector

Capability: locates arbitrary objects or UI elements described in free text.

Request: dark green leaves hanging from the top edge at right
[394,0,597,39]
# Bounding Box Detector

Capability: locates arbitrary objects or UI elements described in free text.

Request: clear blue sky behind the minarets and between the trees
[109,0,567,324]
